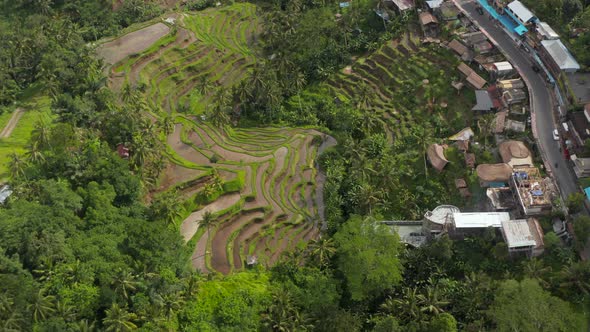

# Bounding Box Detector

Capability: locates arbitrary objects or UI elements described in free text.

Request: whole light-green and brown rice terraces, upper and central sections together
[102,3,335,273]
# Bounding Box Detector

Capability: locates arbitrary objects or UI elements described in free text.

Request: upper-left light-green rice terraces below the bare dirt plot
[110,3,259,112]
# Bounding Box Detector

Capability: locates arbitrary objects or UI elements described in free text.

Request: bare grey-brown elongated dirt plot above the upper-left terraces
[96,23,170,64]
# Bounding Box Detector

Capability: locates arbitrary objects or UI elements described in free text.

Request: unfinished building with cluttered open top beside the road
[510,167,553,216]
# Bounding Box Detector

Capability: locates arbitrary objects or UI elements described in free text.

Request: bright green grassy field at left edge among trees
[0,96,51,182]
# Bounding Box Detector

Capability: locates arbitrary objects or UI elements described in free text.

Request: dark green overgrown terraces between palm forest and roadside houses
[327,32,472,140]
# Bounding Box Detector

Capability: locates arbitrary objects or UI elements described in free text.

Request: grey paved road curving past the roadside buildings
[455,0,578,198]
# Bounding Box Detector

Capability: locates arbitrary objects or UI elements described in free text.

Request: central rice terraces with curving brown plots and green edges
[164,116,335,273]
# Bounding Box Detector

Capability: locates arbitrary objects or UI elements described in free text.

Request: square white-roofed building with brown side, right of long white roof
[501,218,544,257]
